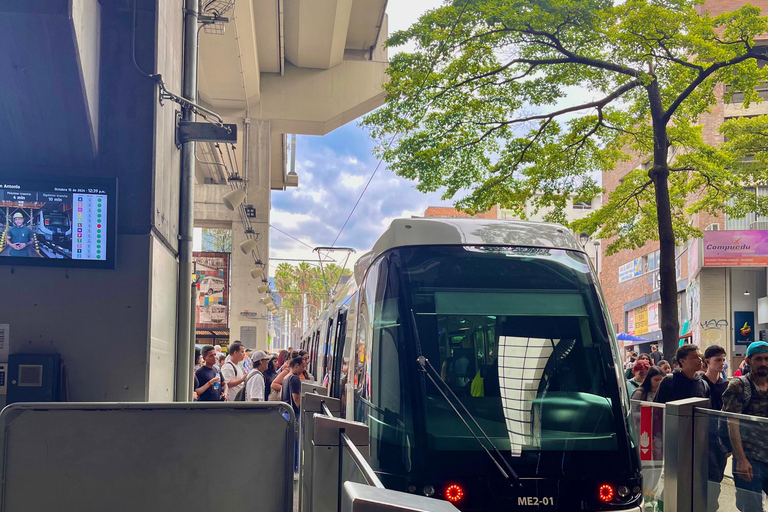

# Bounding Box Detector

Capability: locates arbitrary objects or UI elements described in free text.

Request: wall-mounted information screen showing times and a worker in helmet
[0,174,117,268]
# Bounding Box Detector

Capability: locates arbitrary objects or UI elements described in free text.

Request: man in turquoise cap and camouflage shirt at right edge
[723,341,768,512]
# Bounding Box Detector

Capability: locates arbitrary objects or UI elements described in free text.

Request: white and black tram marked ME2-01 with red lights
[302,219,642,512]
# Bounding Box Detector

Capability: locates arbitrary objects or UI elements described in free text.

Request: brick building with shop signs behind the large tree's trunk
[601,0,768,370]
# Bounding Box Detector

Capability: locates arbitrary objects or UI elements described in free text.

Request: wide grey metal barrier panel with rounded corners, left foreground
[0,402,294,512]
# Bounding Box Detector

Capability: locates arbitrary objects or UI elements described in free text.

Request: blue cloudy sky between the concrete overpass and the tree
[269,0,451,275]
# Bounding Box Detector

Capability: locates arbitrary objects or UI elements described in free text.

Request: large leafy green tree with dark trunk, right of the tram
[364,0,768,360]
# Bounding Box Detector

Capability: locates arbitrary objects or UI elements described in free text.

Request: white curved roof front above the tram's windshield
[370,218,584,261]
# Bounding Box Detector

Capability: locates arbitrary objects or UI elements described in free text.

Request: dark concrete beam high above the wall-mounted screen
[0,0,101,166]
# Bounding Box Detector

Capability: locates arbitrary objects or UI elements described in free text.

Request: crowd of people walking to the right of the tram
[626,341,768,512]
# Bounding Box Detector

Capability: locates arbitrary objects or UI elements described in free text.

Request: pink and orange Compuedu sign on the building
[703,231,768,267]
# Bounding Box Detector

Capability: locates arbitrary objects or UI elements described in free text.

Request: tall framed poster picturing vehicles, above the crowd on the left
[192,252,229,329]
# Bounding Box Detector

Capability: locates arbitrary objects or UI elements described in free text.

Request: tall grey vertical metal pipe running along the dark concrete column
[175,0,198,402]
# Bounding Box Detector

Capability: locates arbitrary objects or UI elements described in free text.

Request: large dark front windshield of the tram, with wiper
[384,246,627,459]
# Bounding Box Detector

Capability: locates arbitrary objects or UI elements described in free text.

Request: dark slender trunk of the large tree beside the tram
[648,82,680,359]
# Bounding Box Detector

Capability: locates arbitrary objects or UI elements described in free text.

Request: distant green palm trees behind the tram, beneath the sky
[275,262,351,330]
